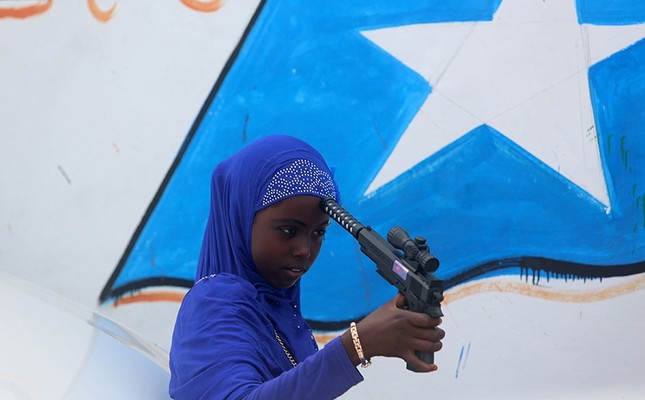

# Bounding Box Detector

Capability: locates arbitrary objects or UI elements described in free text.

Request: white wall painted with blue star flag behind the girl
[0,0,645,399]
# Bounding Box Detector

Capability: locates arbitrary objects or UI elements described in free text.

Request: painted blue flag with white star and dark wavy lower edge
[95,0,645,329]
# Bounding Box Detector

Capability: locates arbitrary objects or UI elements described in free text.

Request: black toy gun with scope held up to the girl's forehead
[320,199,443,369]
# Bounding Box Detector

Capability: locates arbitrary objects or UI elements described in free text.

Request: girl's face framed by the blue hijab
[251,195,329,289]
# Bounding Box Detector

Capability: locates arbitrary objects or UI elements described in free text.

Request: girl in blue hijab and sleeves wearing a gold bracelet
[170,136,444,400]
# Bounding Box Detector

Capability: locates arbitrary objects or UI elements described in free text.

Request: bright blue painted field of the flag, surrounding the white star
[100,0,645,329]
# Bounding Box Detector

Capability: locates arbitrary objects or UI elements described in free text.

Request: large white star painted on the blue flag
[363,0,645,206]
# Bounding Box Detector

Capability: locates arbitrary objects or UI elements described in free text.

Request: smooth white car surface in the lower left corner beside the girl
[0,273,170,400]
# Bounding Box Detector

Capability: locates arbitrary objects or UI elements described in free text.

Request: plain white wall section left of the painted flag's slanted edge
[0,1,257,346]
